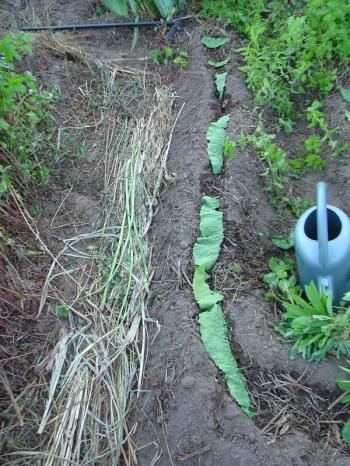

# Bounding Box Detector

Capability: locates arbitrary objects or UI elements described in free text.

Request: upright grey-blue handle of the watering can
[317,182,328,267]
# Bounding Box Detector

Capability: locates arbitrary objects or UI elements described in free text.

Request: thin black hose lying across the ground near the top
[20,18,179,31]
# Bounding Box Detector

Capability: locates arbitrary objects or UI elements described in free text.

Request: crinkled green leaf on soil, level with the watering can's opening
[193,196,224,270]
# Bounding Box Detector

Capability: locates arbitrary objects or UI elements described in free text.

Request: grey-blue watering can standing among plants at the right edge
[294,182,350,304]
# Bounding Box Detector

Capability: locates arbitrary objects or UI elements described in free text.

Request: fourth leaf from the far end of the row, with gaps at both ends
[207,114,231,175]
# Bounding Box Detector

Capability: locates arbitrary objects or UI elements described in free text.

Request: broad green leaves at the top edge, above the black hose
[101,0,184,19]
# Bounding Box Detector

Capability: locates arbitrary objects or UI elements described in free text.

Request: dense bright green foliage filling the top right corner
[202,0,350,127]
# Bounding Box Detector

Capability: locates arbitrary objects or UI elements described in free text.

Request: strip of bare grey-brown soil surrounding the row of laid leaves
[137,28,350,466]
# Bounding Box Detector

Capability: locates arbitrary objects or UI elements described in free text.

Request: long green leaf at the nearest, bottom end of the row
[199,304,252,416]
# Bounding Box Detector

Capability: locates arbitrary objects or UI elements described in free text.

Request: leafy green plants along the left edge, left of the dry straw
[0,33,57,196]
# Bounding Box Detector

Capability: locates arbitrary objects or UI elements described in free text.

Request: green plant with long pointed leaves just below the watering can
[276,282,350,363]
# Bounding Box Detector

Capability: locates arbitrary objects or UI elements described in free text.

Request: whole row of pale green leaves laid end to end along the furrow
[192,36,253,416]
